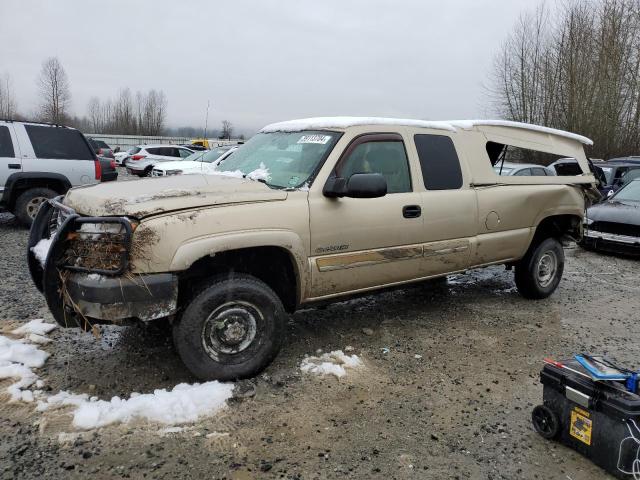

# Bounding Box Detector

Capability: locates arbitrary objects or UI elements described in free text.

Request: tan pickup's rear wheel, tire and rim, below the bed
[515,238,564,300]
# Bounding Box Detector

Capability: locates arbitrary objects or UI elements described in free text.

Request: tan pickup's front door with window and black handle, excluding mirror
[309,133,424,297]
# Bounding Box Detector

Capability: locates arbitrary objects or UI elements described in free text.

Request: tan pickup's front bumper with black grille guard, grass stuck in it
[27,197,178,328]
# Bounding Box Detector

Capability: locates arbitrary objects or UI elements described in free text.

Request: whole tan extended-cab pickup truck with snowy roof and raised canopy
[29,117,598,379]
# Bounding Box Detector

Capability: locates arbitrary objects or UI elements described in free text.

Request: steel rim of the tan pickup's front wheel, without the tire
[202,300,262,359]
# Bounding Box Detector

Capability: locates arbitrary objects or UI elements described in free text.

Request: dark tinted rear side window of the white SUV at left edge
[24,125,95,160]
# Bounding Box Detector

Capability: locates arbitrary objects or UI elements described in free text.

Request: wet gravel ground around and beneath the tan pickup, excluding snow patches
[0,175,640,480]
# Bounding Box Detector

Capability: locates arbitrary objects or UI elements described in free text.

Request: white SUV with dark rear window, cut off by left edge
[0,120,102,225]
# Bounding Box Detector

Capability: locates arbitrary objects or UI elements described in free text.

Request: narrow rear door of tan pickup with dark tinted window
[413,134,478,277]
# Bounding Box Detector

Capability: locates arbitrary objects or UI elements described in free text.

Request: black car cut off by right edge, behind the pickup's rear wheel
[580,178,640,255]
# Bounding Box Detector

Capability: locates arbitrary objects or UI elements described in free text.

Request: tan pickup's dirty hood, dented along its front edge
[64,175,287,218]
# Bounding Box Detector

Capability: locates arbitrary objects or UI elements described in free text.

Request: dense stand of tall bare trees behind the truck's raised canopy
[490,0,640,159]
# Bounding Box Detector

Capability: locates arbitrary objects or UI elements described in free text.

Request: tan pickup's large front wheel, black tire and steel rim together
[173,274,286,380]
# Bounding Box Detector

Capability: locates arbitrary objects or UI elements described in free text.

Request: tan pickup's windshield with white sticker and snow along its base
[218,130,340,188]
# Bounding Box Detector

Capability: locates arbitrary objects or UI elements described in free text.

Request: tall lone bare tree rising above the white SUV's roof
[38,57,71,123]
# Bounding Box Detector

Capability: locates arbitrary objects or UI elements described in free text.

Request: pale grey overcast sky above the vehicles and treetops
[0,0,538,132]
